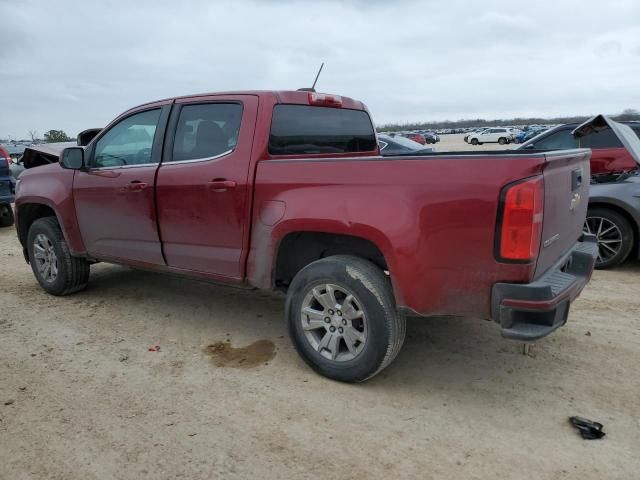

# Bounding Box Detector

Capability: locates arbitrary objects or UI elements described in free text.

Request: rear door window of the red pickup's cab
[169,103,242,162]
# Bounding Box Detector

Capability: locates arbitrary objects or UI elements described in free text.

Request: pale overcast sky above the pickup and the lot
[0,0,640,138]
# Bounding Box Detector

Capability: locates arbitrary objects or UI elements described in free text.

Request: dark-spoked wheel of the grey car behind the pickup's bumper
[584,207,635,270]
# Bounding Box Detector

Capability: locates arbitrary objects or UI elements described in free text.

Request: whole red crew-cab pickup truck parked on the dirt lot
[16,91,597,381]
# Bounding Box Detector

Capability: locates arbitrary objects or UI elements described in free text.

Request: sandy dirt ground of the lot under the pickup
[0,141,640,480]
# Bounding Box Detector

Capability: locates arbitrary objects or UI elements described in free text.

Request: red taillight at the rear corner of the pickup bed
[496,176,544,263]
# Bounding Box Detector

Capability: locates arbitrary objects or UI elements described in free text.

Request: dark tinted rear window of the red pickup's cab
[269,105,377,155]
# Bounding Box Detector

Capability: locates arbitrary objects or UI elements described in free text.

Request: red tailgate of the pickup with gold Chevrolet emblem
[535,149,591,278]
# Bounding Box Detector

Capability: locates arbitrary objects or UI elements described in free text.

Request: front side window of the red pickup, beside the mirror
[91,109,161,168]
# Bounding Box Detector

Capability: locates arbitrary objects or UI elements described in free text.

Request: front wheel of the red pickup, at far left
[27,217,89,296]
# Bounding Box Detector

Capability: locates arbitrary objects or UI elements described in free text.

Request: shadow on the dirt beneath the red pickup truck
[81,265,556,394]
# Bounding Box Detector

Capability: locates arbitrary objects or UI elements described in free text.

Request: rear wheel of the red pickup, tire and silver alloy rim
[285,255,406,382]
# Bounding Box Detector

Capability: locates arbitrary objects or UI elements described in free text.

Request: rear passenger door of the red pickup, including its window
[156,95,258,279]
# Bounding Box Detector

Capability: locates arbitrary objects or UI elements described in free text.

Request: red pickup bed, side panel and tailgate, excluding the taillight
[249,149,590,318]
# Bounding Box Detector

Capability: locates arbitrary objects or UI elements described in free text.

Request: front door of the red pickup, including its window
[73,105,170,265]
